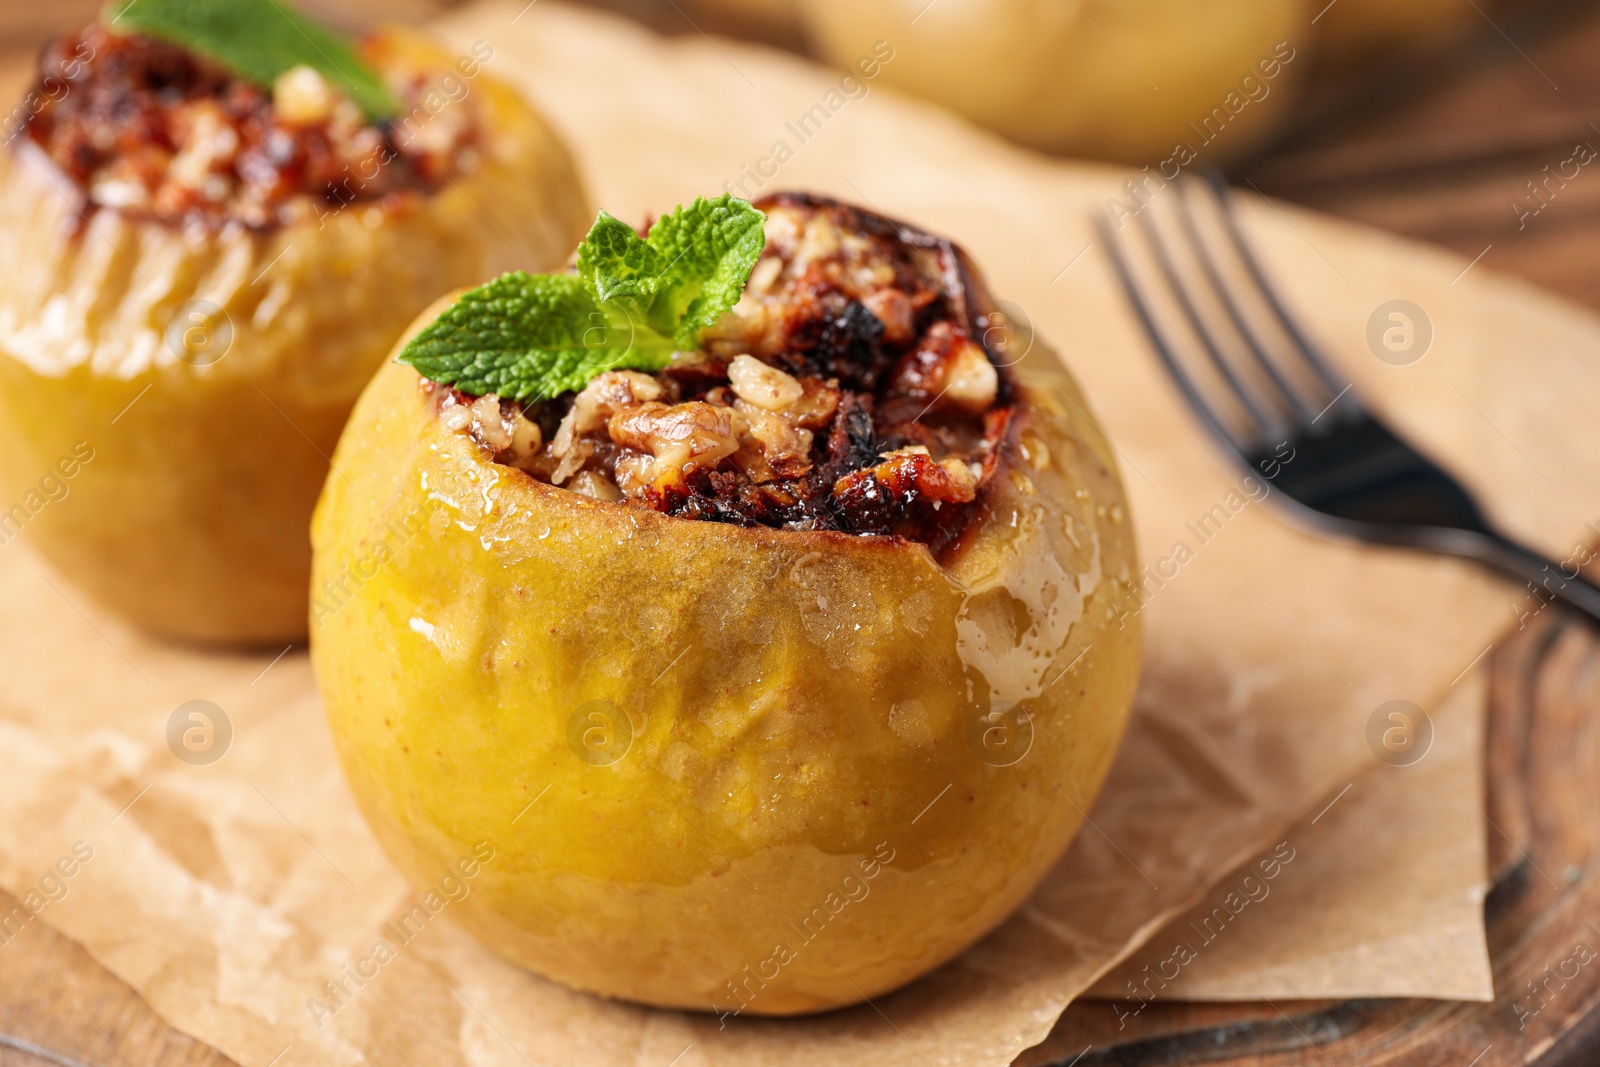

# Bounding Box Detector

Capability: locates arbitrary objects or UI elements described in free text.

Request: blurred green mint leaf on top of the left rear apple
[101,0,400,122]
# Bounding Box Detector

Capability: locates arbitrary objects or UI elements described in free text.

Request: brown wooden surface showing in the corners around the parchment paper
[0,0,1600,1067]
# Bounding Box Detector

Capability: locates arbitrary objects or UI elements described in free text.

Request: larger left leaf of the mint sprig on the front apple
[400,272,677,400]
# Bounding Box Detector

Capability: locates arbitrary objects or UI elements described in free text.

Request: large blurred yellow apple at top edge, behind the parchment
[800,0,1309,163]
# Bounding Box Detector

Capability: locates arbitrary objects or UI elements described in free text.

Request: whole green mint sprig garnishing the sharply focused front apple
[398,195,766,400]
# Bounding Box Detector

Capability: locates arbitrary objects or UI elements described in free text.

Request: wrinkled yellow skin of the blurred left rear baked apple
[0,29,589,645]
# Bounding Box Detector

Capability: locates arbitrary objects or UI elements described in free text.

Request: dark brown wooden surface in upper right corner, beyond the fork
[1230,0,1600,319]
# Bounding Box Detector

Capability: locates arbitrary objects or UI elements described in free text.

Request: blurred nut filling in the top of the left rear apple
[16,24,480,230]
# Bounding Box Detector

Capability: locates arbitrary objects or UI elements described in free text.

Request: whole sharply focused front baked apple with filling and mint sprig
[312,194,1139,1014]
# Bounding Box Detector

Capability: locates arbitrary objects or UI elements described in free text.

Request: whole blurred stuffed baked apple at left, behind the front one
[0,0,589,643]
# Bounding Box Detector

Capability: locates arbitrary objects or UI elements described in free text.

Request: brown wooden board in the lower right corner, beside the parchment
[1016,611,1600,1067]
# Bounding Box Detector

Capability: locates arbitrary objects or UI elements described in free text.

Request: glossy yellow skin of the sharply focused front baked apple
[312,299,1139,1014]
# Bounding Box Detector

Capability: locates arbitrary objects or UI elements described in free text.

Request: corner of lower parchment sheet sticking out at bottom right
[1086,667,1494,1017]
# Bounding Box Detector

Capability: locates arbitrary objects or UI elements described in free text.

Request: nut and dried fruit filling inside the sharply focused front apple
[424,194,1016,552]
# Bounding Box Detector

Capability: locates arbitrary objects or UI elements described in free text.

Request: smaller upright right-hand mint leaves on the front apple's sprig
[578,194,766,349]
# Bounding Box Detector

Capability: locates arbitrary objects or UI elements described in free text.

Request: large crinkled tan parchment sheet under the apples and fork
[0,2,1600,1067]
